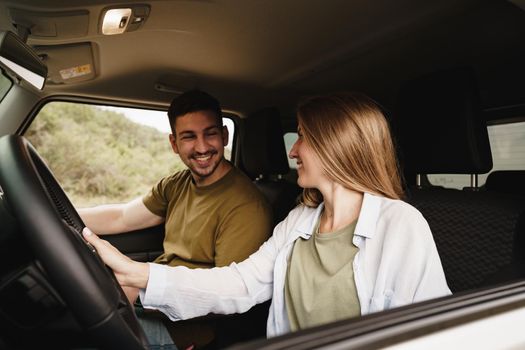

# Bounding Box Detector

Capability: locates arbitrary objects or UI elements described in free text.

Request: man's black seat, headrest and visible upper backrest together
[241,107,301,224]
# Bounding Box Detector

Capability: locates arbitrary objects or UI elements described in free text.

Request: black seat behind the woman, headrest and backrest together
[394,69,525,291]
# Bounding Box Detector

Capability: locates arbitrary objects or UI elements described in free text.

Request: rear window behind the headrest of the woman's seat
[428,122,525,189]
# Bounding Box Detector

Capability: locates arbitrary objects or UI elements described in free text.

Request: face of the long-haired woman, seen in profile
[288,125,325,189]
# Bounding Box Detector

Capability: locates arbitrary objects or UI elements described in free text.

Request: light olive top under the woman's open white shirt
[285,221,361,331]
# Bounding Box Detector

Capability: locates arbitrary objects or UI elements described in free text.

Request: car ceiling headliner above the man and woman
[0,0,525,117]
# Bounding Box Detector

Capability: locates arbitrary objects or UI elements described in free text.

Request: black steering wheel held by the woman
[0,135,147,349]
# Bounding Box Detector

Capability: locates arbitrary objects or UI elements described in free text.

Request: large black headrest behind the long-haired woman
[394,68,492,178]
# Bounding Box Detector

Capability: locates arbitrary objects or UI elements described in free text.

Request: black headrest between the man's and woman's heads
[241,107,290,179]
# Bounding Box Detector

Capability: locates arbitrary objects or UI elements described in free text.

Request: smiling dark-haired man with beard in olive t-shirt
[79,90,272,348]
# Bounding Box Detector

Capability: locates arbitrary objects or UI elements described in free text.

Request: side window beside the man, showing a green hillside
[25,102,235,207]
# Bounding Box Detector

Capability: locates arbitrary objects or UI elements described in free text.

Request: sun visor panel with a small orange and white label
[35,43,96,84]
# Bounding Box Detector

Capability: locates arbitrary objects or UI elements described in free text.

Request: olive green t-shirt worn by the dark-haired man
[143,167,272,268]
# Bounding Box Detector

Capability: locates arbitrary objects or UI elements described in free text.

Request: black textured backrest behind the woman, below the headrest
[408,188,525,292]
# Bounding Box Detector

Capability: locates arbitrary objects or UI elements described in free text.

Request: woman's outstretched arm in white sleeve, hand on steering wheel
[84,219,284,321]
